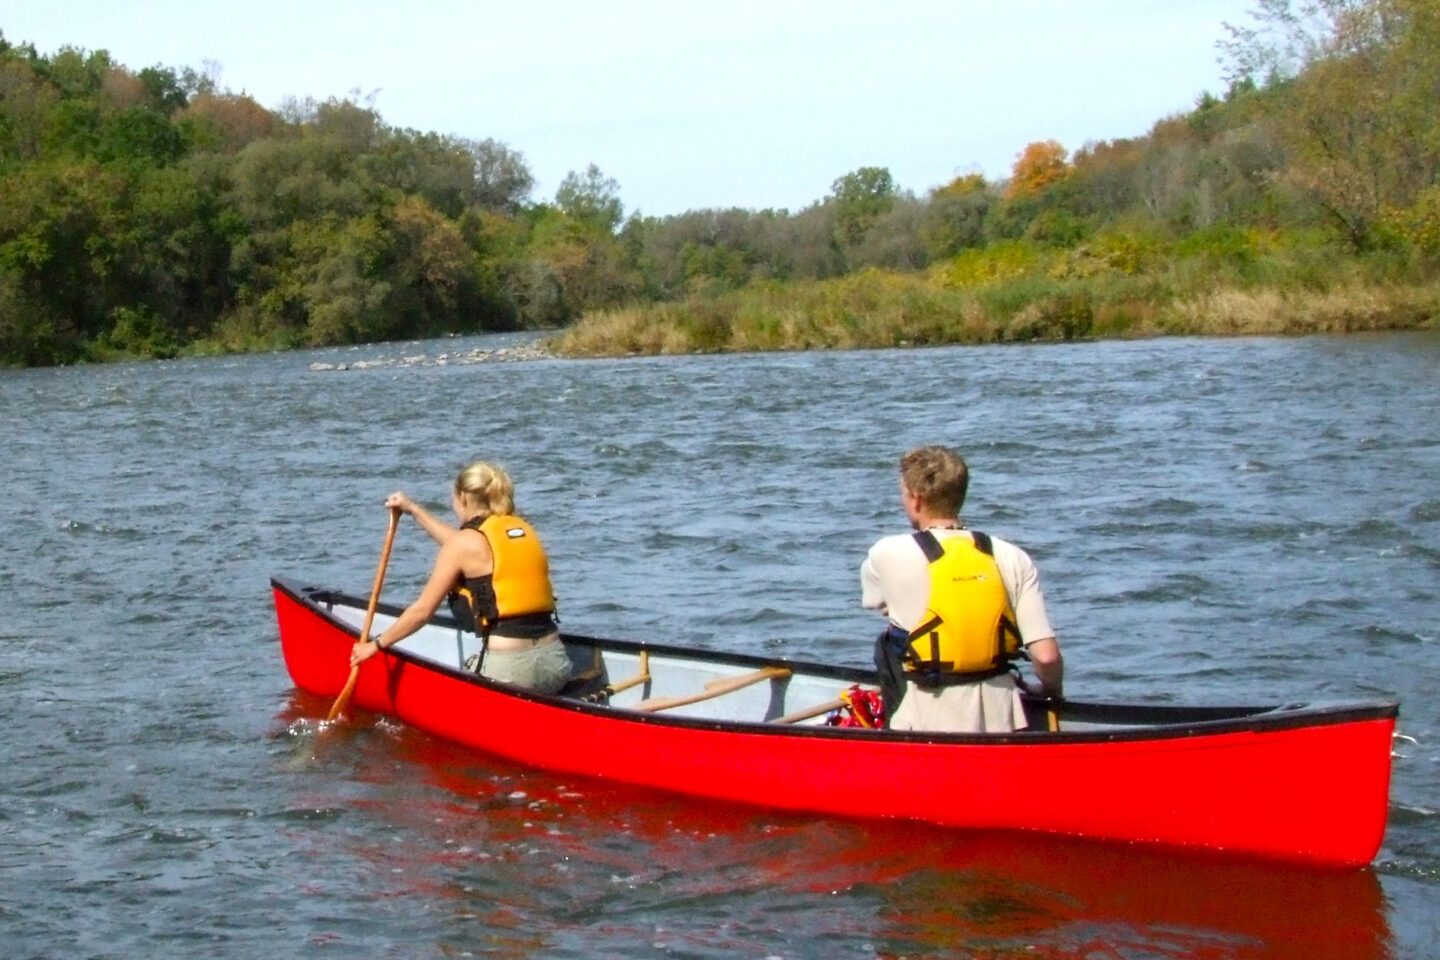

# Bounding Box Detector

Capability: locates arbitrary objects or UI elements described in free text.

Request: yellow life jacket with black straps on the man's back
[903,530,1020,687]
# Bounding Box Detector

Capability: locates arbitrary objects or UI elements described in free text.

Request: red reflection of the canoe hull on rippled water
[287,705,1391,960]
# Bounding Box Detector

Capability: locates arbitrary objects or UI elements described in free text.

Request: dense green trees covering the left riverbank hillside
[0,36,639,366]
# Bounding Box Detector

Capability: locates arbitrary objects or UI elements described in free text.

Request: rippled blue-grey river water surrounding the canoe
[0,334,1440,960]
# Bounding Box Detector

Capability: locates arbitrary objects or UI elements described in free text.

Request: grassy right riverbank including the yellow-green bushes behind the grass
[547,242,1440,357]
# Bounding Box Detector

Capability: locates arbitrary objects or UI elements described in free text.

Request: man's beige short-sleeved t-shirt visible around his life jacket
[860,530,1056,733]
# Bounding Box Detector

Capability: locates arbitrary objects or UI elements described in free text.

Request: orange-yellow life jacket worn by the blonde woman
[451,514,556,638]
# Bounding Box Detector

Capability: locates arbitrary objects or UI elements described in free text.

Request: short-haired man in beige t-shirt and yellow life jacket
[860,446,1064,733]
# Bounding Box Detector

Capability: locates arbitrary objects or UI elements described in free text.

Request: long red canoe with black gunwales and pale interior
[271,579,1398,866]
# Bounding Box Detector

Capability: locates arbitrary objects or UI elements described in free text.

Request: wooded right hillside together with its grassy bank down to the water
[554,0,1440,354]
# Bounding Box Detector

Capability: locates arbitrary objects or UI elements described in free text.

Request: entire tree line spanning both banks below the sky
[0,0,1440,366]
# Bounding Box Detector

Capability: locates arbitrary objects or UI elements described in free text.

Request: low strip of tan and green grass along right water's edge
[546,264,1440,357]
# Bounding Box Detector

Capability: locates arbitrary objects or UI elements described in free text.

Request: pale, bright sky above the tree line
[0,0,1254,216]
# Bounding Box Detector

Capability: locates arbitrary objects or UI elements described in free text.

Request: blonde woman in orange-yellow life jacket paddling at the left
[350,461,572,694]
